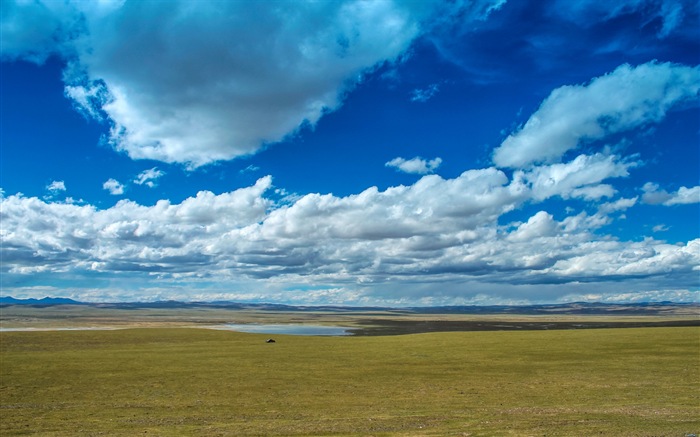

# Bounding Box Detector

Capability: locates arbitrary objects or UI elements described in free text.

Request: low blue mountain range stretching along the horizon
[0,296,700,315]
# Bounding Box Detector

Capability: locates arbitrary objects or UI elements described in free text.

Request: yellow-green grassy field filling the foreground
[0,327,700,437]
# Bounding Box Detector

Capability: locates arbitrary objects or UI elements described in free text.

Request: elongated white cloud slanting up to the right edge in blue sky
[493,62,700,168]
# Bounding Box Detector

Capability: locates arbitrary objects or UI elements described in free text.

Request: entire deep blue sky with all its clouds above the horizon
[0,0,700,307]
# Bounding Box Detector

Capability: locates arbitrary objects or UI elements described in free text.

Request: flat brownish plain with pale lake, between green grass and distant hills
[0,304,700,336]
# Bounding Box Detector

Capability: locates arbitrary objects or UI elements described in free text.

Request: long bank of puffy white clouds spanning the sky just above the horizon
[0,168,700,304]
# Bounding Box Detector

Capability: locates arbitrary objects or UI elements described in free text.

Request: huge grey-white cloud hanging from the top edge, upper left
[2,0,501,167]
